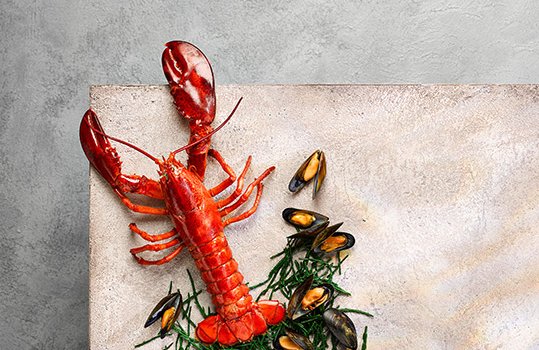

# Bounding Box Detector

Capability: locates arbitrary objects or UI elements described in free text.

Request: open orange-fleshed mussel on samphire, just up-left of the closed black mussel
[286,276,335,320]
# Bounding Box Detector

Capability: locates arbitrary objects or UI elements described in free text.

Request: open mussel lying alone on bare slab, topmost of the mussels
[288,150,326,199]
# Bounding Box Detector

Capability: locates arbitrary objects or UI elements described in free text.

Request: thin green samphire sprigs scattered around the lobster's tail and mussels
[135,239,373,350]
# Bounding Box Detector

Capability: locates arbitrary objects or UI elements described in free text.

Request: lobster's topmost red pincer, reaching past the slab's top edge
[162,41,215,125]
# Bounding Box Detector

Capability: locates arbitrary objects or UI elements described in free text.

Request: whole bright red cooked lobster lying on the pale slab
[80,41,285,346]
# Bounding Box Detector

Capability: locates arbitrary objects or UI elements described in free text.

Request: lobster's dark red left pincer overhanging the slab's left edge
[79,109,122,188]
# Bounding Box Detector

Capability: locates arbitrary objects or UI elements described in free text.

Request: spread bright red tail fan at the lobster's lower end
[196,300,285,346]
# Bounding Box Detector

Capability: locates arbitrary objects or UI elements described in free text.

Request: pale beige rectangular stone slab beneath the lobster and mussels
[90,85,539,349]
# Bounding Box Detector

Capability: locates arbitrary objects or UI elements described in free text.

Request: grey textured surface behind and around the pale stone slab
[0,0,539,349]
